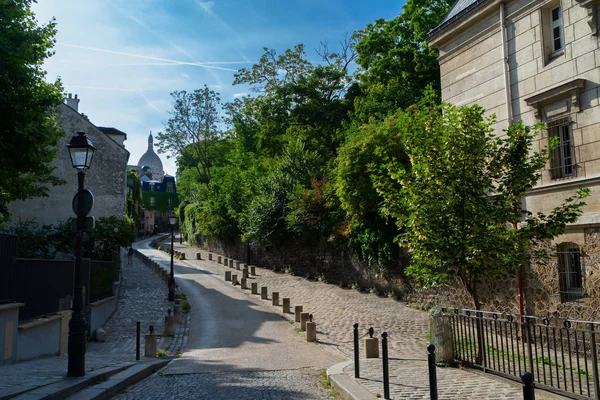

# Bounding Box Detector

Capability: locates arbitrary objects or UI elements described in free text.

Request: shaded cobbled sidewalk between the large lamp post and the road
[88,250,189,360]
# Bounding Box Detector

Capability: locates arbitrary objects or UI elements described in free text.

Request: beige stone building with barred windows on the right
[429,0,600,319]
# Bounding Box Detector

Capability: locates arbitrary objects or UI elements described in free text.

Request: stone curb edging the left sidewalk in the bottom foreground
[69,359,171,400]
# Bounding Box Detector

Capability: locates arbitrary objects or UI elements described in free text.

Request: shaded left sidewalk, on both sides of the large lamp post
[0,241,188,397]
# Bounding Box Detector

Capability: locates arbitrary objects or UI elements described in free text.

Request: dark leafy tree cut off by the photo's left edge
[0,0,64,222]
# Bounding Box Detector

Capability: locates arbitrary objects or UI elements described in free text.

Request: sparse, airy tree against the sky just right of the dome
[157,85,223,184]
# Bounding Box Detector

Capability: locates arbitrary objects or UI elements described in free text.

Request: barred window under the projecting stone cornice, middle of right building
[548,117,577,179]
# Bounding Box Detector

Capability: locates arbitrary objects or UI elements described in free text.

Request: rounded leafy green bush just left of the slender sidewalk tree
[335,115,410,273]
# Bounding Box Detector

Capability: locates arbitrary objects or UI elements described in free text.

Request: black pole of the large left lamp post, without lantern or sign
[67,170,87,376]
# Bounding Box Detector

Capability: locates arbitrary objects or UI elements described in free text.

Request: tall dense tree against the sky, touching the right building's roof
[354,0,454,123]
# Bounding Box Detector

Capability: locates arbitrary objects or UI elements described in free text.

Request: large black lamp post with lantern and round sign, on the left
[67,131,96,376]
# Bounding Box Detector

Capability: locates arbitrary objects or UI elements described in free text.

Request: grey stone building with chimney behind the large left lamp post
[10,94,129,225]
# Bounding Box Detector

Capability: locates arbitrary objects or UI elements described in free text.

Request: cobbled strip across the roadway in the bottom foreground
[115,368,333,400]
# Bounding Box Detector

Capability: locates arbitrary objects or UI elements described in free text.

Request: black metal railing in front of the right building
[442,308,600,399]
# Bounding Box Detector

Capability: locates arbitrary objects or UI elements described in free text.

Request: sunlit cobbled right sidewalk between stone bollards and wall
[164,242,563,399]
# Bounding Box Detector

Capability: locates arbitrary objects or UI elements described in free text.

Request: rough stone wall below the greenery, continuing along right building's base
[202,234,600,321]
